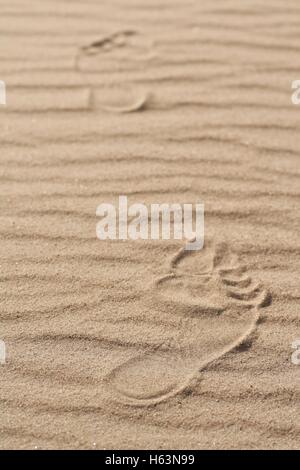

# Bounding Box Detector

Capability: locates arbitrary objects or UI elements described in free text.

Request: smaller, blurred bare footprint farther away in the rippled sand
[76,30,156,114]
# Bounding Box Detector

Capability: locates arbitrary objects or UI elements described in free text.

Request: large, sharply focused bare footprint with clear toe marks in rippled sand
[106,243,270,406]
